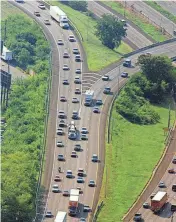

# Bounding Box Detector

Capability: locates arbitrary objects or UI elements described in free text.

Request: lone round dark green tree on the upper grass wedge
[95,14,126,49]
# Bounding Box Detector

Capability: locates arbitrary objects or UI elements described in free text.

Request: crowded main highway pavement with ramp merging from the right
[11,1,176,221]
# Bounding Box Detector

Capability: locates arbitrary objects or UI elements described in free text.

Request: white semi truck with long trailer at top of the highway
[50,6,69,29]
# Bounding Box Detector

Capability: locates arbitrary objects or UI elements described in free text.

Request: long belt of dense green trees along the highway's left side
[1,16,49,222]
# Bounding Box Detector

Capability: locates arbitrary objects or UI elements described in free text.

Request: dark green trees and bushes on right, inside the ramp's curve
[116,55,176,124]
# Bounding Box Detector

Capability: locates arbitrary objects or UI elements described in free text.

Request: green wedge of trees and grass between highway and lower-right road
[97,56,176,222]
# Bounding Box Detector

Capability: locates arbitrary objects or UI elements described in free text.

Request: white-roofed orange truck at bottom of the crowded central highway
[68,189,79,216]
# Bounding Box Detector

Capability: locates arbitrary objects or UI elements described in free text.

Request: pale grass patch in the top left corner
[1,1,29,20]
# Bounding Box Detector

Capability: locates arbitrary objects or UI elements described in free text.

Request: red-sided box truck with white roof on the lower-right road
[151,191,168,213]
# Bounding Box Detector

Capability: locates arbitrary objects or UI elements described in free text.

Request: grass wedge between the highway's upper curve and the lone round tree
[48,1,132,71]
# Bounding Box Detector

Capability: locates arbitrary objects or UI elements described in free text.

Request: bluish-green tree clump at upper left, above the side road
[2,15,49,69]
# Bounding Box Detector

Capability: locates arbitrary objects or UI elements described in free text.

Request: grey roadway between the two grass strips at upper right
[127,1,175,36]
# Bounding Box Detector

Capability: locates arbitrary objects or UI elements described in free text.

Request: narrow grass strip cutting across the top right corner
[145,1,176,23]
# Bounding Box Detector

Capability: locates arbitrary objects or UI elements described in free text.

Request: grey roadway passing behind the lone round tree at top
[88,1,152,48]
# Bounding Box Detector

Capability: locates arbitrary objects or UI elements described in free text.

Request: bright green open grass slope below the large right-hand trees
[97,106,174,222]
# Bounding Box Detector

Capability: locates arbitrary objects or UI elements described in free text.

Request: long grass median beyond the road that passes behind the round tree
[103,1,168,42]
